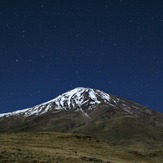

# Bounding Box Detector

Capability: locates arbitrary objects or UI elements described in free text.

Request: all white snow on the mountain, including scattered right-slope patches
[0,87,158,117]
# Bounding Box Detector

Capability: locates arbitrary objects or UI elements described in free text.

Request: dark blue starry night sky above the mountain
[0,0,163,113]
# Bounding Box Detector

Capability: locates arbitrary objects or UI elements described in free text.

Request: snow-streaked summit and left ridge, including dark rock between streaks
[0,87,110,117]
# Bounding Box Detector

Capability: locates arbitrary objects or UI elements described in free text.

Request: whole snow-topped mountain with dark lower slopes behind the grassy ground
[0,87,163,144]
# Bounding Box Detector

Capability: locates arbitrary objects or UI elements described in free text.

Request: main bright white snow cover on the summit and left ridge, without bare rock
[0,87,110,117]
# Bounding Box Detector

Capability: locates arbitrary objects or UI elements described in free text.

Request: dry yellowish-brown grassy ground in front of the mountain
[0,132,163,163]
